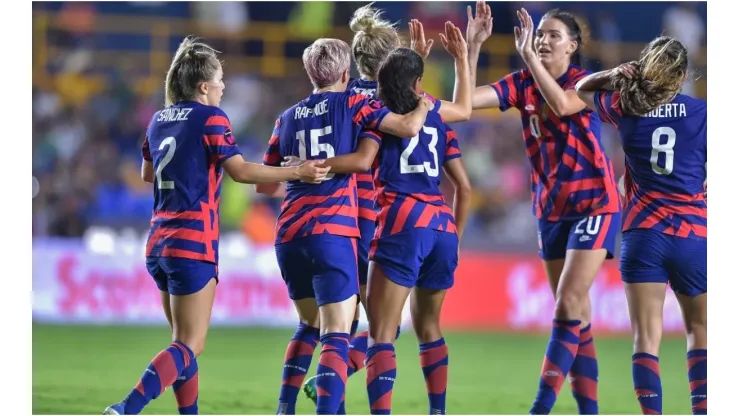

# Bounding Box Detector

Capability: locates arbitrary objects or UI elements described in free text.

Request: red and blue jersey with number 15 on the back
[263,91,389,243]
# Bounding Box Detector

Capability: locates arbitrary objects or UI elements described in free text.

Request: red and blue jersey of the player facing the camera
[491,65,620,221]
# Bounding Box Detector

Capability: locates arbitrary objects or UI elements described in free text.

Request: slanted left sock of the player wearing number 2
[124,341,195,415]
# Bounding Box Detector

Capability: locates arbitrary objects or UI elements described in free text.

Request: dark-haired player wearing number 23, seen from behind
[312,22,471,414]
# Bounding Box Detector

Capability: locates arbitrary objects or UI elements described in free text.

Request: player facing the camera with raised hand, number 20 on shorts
[466,9,620,414]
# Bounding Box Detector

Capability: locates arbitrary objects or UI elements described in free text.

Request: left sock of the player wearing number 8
[632,352,663,415]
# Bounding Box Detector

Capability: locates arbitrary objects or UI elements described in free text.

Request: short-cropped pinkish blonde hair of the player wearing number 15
[303,38,350,88]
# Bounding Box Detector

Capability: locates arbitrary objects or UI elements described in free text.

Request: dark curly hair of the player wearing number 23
[378,48,424,114]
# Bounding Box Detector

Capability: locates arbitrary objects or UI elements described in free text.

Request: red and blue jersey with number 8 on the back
[594,91,707,238]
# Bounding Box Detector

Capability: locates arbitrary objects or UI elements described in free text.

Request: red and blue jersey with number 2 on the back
[142,102,240,263]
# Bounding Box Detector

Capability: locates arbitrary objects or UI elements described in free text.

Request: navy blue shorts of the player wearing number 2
[146,257,218,296]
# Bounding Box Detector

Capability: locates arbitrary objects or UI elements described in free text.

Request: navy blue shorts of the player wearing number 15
[275,234,360,306]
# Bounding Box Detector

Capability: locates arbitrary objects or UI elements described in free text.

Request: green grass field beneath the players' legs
[33,325,691,414]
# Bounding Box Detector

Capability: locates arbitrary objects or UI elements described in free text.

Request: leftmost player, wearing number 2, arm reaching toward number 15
[104,37,328,415]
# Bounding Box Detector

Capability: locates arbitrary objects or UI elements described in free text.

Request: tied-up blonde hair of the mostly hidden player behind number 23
[349,3,401,79]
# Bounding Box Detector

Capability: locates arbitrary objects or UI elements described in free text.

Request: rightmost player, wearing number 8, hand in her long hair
[576,36,707,415]
